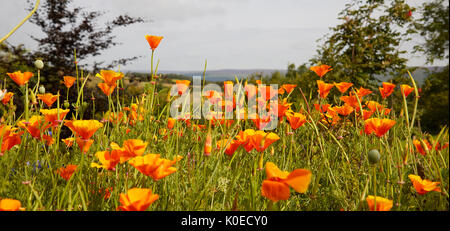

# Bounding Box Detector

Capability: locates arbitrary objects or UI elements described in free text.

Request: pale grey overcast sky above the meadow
[0,0,444,71]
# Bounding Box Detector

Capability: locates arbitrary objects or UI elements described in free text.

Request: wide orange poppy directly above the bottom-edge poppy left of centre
[128,154,183,180]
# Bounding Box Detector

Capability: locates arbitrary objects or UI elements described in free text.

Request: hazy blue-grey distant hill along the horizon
[126,66,444,85]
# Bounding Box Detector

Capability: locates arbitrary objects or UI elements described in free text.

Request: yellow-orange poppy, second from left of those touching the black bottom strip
[117,188,159,211]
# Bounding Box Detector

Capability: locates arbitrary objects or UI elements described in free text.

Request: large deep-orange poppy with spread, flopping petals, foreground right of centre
[261,162,311,202]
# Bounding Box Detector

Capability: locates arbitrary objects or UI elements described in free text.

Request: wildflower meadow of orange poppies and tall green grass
[0,0,449,214]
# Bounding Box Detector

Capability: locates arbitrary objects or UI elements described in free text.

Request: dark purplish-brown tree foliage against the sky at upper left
[26,0,144,74]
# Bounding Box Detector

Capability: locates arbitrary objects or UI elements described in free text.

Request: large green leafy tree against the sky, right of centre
[310,0,414,89]
